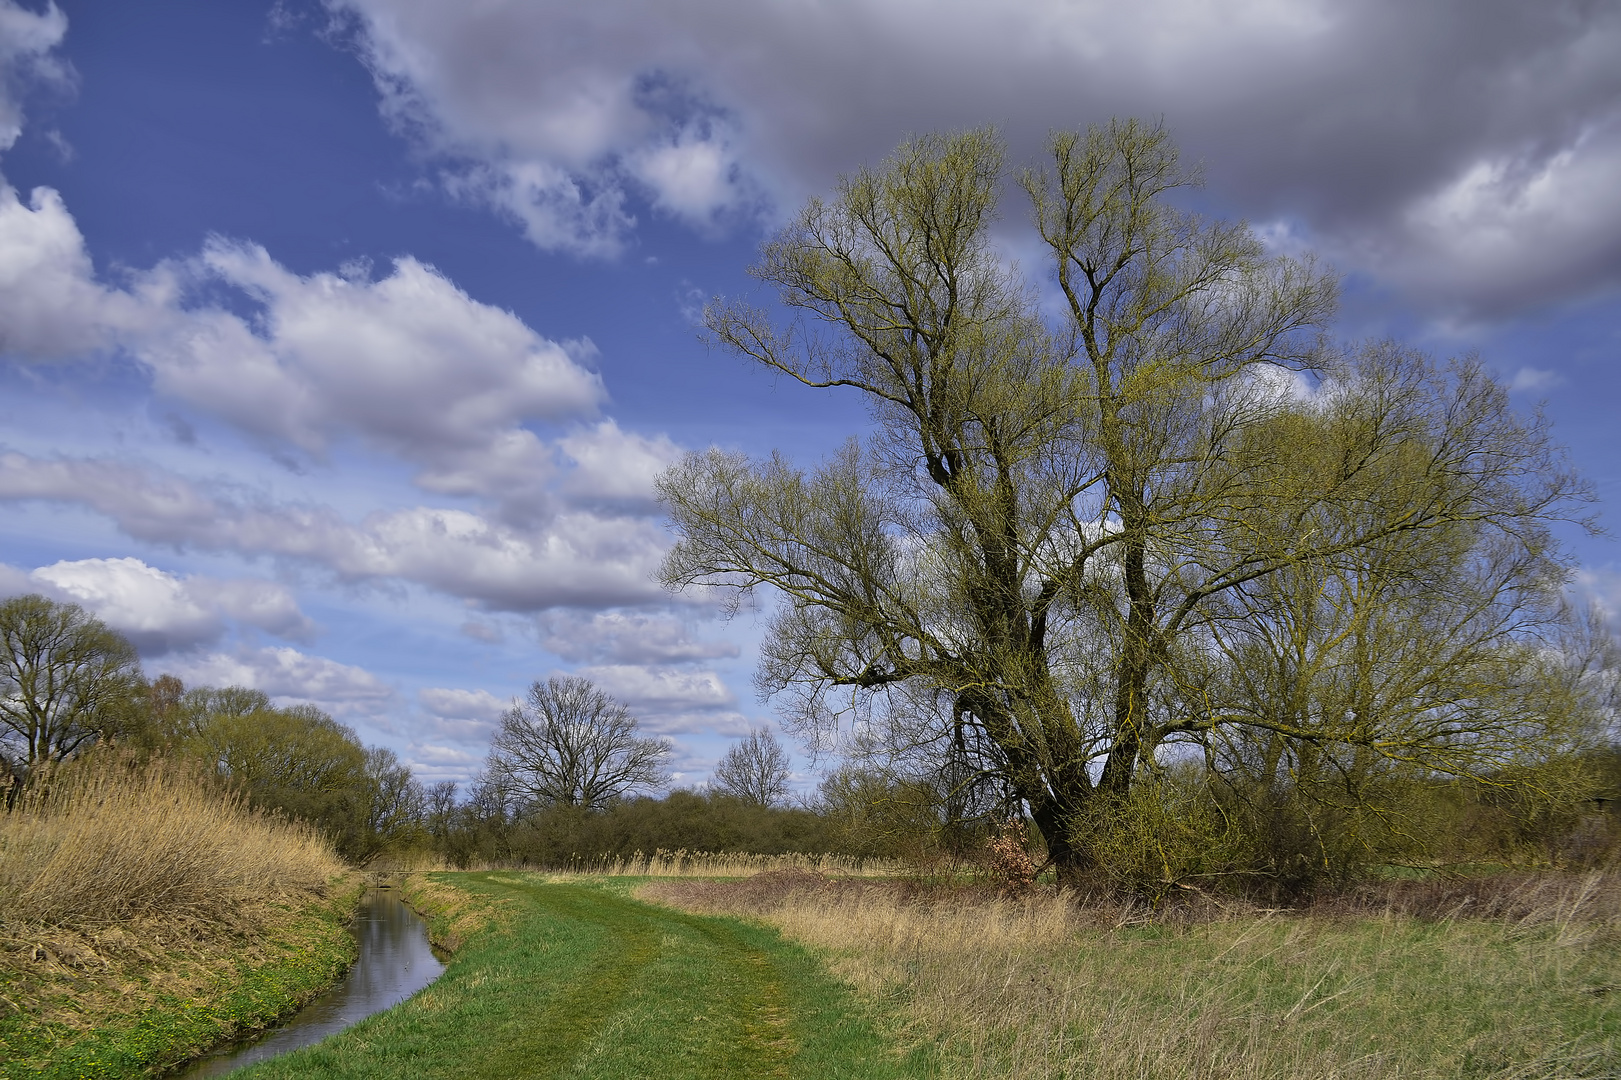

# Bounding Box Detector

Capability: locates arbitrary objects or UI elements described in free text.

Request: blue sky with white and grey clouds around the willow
[0,0,1621,786]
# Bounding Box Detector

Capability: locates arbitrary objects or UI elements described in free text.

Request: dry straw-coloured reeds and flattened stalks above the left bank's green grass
[0,756,349,1031]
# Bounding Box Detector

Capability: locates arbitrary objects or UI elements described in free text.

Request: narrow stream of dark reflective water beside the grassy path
[175,889,444,1080]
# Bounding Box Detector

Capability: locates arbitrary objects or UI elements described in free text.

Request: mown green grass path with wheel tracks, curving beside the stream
[233,874,934,1080]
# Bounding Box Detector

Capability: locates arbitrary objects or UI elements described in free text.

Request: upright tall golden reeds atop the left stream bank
[0,754,344,926]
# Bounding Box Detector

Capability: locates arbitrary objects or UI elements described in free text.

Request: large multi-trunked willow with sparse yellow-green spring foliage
[660,122,1580,877]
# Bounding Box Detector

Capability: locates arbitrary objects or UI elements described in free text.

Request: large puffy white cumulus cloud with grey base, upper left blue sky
[136,240,603,461]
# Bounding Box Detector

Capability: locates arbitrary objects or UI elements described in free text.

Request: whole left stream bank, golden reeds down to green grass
[0,759,360,1078]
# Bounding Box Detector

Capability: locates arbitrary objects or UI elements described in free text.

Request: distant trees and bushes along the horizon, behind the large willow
[0,595,1621,897]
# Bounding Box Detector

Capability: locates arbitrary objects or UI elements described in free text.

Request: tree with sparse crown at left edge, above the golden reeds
[0,594,141,770]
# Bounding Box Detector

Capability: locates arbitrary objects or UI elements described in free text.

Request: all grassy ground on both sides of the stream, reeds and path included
[0,756,1621,1080]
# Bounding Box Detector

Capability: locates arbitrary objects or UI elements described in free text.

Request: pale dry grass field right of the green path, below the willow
[640,874,1621,1080]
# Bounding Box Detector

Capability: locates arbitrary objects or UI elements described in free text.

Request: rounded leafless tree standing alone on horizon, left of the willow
[488,678,669,809]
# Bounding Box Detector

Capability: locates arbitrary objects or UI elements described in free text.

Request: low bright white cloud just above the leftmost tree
[0,558,314,657]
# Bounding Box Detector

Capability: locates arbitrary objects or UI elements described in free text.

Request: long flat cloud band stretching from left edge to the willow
[0,452,666,611]
